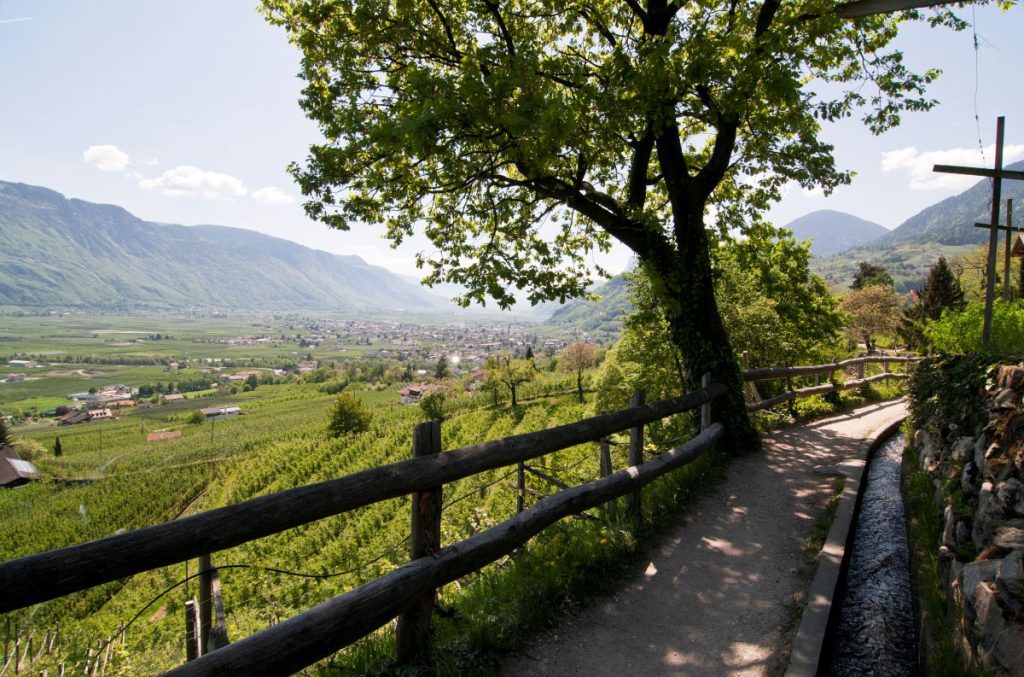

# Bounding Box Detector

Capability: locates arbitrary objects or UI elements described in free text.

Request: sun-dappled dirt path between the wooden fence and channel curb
[501,401,905,677]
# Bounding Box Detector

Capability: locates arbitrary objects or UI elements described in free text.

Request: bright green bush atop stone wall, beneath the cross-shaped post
[925,299,1024,355]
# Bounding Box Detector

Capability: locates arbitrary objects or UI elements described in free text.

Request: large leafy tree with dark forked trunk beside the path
[263,0,957,448]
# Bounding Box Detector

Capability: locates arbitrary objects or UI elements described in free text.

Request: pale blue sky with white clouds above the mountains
[0,0,1024,277]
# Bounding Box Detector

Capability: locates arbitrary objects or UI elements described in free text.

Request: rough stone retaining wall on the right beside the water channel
[913,364,1024,676]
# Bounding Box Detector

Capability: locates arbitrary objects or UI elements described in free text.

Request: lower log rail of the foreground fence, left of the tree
[164,421,723,677]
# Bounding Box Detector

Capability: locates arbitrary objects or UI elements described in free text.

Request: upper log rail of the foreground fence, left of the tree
[0,384,727,610]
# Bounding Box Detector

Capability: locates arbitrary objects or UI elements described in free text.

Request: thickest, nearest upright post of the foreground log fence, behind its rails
[394,419,441,664]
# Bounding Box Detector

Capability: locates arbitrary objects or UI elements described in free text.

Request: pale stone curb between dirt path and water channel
[785,398,907,677]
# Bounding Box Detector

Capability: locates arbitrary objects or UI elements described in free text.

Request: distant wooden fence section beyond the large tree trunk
[743,353,921,412]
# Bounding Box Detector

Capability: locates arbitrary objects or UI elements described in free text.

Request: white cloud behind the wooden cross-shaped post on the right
[882,145,1024,191]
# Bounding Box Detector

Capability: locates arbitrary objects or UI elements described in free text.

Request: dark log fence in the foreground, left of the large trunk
[0,376,726,675]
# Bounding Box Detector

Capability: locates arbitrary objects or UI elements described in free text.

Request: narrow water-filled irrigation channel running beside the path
[828,434,918,677]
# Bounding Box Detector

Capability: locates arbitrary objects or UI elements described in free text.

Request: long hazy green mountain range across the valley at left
[0,181,456,312]
